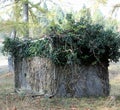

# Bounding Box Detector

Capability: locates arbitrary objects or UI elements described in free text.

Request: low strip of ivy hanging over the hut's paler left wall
[2,38,50,60]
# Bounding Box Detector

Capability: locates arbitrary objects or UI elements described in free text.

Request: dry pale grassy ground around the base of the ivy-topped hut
[0,65,120,110]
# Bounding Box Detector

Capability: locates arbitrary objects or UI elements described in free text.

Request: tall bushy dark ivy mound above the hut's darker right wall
[49,13,120,65]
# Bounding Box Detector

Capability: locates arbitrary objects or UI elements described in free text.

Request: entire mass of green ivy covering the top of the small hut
[3,14,120,66]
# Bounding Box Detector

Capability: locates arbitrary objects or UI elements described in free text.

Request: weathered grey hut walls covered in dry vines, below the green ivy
[15,57,109,97]
